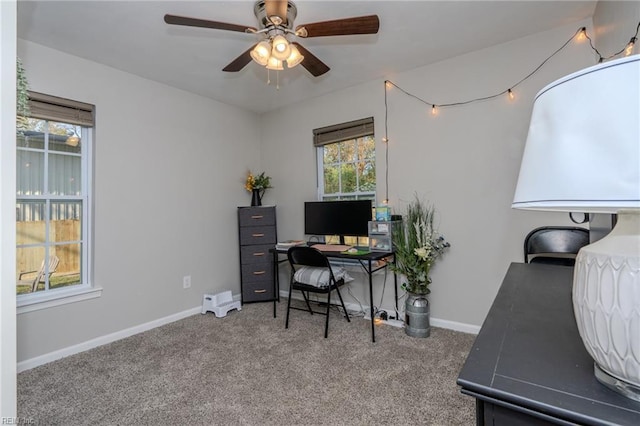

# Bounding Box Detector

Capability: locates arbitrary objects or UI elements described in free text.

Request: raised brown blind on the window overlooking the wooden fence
[29,91,94,127]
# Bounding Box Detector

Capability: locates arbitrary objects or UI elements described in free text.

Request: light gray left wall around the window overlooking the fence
[17,40,260,361]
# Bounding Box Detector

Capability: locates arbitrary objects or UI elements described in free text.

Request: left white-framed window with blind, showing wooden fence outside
[16,93,93,305]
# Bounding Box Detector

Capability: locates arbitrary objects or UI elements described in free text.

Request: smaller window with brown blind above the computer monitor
[313,117,376,246]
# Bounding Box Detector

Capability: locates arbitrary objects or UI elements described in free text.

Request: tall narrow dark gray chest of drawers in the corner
[238,206,278,303]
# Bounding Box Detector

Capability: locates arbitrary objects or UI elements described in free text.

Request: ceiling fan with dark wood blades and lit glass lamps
[164,0,380,77]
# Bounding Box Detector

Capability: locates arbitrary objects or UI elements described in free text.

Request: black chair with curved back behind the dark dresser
[524,226,589,266]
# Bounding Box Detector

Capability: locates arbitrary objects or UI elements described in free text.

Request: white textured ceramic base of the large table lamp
[573,209,640,401]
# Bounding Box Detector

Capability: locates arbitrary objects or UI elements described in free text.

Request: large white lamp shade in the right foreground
[512,55,640,213]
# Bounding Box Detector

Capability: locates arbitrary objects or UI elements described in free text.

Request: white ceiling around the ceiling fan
[18,0,596,113]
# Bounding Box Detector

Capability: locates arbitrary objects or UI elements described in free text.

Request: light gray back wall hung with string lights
[262,21,594,331]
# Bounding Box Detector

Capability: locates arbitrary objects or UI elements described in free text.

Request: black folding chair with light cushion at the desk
[285,246,351,339]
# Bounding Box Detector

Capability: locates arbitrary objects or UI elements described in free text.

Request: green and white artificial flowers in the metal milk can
[391,196,451,294]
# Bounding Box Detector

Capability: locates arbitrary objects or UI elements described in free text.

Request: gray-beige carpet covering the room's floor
[18,299,475,425]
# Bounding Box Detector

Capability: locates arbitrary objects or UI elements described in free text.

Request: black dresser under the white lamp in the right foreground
[457,263,640,426]
